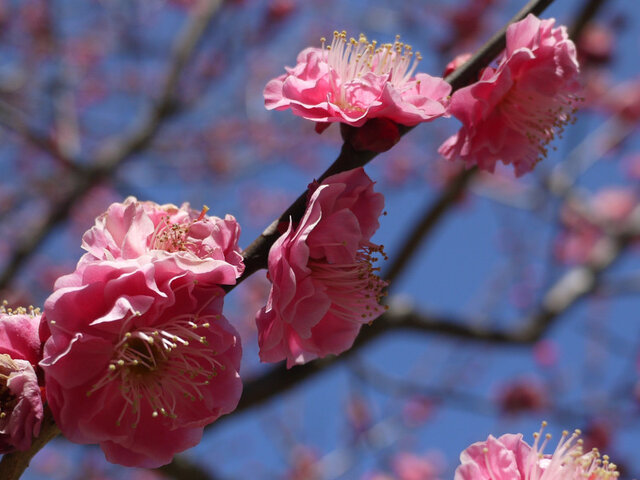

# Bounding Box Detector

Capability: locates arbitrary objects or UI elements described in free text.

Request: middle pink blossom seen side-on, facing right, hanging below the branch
[256,168,386,368]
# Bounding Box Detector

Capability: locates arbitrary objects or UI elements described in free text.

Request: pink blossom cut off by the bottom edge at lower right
[454,423,619,480]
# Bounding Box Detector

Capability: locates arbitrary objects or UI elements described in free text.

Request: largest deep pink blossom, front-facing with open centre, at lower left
[41,260,242,468]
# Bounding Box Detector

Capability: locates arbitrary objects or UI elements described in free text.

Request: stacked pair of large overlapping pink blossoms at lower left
[40,198,244,468]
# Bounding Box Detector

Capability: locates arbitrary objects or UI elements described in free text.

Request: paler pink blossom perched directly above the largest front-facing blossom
[81,197,244,285]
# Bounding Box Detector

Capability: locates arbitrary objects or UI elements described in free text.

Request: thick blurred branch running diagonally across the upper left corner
[0,0,222,290]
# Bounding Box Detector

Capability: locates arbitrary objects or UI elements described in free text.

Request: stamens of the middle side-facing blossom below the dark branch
[308,243,388,323]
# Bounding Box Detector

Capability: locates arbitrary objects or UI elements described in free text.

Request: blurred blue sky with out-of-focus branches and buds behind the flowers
[0,0,640,480]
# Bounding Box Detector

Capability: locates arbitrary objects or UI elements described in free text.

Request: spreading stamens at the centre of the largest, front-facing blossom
[87,314,225,428]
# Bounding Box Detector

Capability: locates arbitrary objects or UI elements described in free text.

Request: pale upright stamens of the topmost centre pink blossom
[320,31,422,102]
